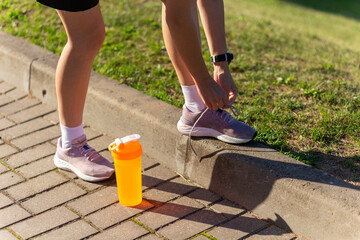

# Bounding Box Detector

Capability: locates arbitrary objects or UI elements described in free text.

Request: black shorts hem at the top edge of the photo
[37,0,99,12]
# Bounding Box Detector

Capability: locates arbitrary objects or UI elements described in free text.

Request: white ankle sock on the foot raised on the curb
[181,85,206,113]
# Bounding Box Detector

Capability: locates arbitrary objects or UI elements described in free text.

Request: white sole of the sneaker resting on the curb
[177,120,252,144]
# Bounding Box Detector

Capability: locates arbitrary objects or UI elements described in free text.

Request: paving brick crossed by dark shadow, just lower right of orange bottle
[136,197,203,230]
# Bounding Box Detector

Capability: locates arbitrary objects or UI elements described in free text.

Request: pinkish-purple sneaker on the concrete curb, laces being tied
[177,105,256,144]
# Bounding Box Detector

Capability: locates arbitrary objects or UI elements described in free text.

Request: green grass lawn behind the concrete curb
[0,0,360,181]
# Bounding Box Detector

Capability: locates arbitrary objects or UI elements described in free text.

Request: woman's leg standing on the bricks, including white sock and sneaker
[54,5,114,182]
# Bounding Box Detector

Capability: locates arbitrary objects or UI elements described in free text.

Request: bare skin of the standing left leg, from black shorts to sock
[55,5,105,127]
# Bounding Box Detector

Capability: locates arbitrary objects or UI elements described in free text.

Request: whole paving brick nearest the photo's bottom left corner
[11,207,79,239]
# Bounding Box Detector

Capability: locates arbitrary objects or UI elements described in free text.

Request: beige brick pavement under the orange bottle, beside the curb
[0,80,299,240]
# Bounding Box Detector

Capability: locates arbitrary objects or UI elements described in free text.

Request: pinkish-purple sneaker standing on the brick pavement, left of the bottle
[54,135,114,182]
